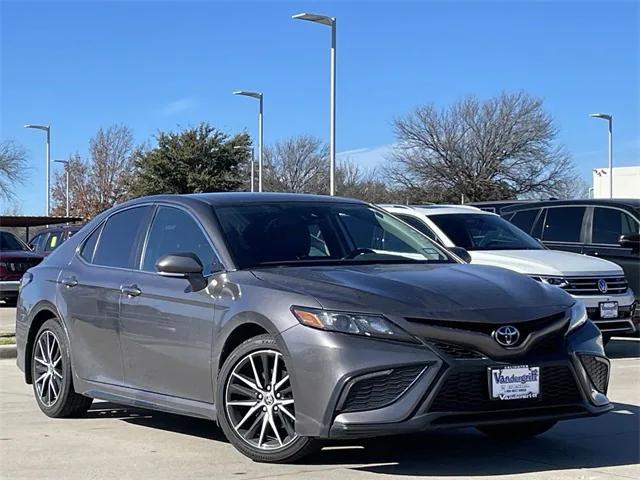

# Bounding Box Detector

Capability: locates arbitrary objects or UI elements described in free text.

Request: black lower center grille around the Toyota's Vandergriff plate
[430,366,580,412]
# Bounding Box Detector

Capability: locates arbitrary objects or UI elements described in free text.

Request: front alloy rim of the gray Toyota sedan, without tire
[225,350,297,450]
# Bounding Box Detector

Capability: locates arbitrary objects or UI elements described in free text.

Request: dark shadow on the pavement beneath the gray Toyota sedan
[87,402,640,478]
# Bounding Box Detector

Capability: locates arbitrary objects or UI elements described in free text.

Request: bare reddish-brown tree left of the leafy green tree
[52,125,134,219]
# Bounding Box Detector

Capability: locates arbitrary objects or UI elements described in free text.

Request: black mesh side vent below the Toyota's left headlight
[340,365,425,412]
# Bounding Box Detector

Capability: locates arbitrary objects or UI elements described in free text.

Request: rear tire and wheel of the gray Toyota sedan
[31,319,93,418]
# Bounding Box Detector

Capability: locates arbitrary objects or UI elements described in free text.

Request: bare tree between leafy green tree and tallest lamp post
[263,135,329,193]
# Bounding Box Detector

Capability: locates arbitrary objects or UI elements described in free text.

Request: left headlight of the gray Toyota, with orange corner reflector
[291,307,418,343]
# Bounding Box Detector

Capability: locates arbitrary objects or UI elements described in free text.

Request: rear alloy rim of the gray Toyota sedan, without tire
[33,330,63,407]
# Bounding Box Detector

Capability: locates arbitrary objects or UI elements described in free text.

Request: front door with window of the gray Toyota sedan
[120,206,217,403]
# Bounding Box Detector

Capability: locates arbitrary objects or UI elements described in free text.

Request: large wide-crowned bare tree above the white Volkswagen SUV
[388,92,574,201]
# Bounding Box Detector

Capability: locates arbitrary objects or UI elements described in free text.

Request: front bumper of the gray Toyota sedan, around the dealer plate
[282,322,613,438]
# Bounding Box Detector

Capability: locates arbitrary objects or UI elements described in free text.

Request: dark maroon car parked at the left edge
[0,230,43,304]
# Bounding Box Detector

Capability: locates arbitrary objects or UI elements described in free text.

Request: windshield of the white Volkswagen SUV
[429,213,544,250]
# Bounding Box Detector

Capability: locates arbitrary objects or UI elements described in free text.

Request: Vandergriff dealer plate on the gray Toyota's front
[489,365,540,400]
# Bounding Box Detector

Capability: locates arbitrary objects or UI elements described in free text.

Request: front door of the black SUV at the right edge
[585,207,640,294]
